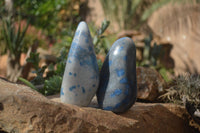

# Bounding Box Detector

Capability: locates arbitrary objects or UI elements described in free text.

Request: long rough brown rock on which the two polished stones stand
[0,79,195,133]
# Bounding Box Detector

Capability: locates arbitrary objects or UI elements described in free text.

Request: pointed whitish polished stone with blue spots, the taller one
[60,22,99,106]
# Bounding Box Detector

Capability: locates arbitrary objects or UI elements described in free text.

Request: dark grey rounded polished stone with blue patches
[97,37,137,113]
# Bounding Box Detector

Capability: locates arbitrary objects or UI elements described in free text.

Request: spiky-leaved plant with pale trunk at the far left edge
[0,1,29,82]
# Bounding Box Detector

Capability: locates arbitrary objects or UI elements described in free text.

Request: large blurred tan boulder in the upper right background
[148,4,200,75]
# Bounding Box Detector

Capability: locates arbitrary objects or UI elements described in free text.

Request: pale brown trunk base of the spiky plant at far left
[6,52,22,82]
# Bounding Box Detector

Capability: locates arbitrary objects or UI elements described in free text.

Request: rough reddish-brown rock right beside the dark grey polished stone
[136,67,165,101]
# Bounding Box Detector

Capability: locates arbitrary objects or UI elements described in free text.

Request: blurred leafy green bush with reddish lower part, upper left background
[0,0,81,51]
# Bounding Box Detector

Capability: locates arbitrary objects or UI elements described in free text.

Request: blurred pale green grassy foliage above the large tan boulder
[100,0,199,29]
